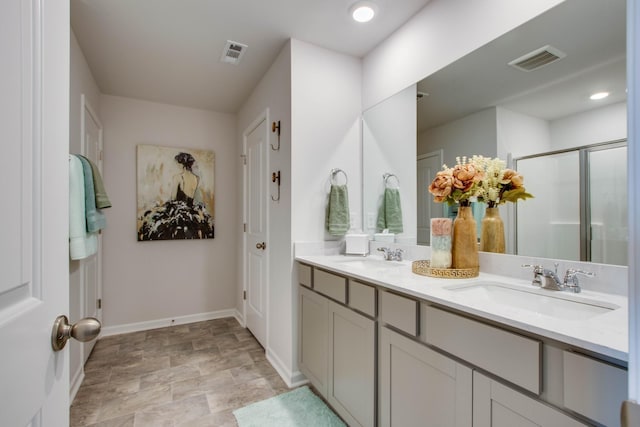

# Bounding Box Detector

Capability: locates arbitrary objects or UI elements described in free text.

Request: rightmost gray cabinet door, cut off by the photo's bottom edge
[473,372,588,427]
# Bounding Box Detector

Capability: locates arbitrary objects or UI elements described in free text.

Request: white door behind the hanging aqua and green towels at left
[80,95,102,363]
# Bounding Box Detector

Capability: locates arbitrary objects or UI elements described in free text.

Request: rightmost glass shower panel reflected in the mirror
[588,146,628,265]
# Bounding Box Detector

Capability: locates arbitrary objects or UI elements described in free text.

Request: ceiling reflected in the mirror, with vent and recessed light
[418,0,626,132]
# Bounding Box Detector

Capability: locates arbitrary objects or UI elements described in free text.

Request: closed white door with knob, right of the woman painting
[244,115,269,348]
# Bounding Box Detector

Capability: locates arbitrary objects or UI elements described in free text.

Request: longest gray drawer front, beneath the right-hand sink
[422,305,542,394]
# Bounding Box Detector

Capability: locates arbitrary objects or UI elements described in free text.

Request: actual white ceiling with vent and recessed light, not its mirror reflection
[71,0,429,113]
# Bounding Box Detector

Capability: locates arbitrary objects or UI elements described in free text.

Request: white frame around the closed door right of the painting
[241,108,271,344]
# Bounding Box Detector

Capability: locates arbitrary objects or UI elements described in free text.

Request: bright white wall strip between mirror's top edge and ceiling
[362,0,563,109]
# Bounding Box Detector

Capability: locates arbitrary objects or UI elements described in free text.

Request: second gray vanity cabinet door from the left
[327,302,376,427]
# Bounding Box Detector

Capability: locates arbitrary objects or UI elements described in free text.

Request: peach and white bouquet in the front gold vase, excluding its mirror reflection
[429,157,484,205]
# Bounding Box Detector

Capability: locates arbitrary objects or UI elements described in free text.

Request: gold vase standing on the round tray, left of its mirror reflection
[451,205,480,268]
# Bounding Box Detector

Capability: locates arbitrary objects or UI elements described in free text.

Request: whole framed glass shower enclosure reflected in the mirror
[515,141,627,265]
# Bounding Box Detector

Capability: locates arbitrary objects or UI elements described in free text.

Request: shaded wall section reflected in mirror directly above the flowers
[418,108,497,167]
